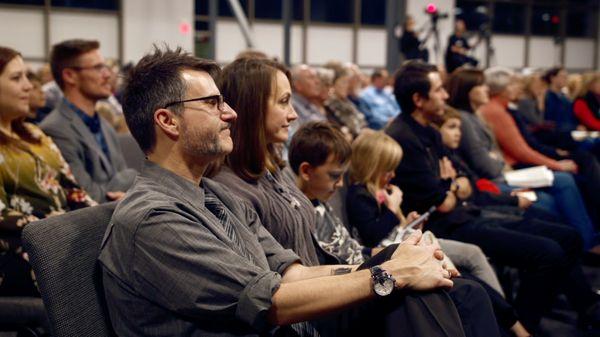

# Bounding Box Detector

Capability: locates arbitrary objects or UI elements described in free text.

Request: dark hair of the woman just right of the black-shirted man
[446,68,485,112]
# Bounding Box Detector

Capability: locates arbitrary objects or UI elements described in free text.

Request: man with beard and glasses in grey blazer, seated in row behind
[40,39,137,202]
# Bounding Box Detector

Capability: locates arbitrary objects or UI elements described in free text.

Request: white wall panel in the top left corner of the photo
[0,8,45,58]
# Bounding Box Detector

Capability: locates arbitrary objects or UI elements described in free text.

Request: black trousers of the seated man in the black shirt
[447,215,596,331]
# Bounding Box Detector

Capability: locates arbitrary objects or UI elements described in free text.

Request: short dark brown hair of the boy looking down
[288,121,352,174]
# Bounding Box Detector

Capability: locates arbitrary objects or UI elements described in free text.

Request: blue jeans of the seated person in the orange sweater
[499,171,598,250]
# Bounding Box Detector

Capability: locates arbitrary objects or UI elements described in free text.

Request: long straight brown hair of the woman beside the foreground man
[217,58,291,181]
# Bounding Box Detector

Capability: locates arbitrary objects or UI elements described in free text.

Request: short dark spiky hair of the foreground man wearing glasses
[123,46,221,154]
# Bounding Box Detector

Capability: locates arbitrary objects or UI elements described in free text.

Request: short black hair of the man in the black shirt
[394,60,438,114]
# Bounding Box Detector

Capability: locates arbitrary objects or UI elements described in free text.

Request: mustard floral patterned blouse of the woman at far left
[0,124,97,294]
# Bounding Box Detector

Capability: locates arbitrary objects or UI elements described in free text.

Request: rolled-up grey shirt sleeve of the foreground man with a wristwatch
[133,209,281,331]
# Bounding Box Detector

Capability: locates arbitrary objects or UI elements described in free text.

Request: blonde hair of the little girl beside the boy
[350,129,402,195]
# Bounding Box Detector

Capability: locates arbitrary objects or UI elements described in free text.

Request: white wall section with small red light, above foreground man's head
[121,0,194,62]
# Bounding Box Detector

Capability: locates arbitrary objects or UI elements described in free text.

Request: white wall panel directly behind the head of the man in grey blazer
[50,11,119,59]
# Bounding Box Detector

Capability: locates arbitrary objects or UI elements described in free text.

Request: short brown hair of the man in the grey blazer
[50,39,100,89]
